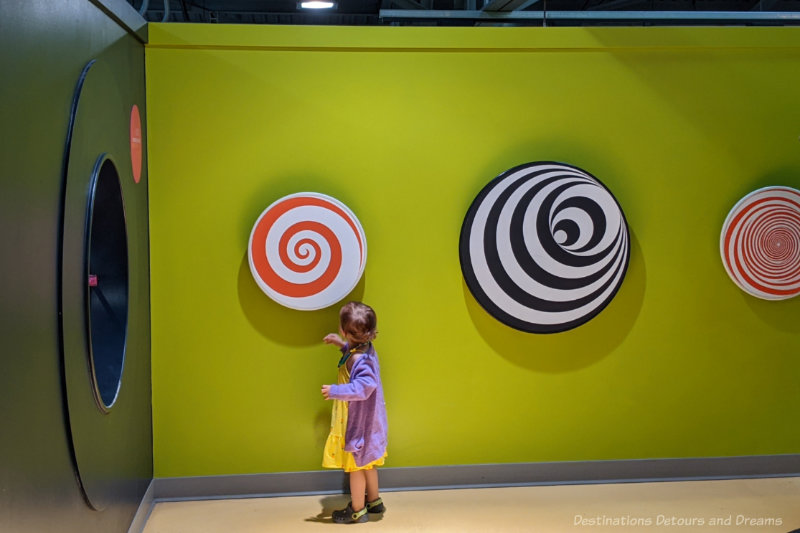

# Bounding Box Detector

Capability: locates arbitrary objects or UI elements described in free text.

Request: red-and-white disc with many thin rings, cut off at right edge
[719,187,800,300]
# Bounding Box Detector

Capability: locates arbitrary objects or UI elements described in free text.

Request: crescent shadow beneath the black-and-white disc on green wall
[463,231,647,373]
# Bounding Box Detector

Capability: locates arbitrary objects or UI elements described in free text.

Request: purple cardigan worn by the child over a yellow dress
[329,344,389,467]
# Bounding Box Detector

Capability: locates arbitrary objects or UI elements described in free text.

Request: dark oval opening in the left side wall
[85,154,128,412]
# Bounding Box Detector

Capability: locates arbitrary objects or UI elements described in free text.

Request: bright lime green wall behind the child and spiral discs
[146,24,800,477]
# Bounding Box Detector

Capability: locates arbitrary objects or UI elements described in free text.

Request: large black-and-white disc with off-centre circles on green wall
[459,162,630,333]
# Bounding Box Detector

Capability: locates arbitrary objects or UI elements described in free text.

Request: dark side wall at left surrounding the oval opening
[0,0,152,533]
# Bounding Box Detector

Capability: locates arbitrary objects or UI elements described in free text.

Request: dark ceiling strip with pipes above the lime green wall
[127,0,800,26]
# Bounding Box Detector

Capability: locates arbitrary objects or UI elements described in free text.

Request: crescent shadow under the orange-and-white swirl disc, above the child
[238,250,367,346]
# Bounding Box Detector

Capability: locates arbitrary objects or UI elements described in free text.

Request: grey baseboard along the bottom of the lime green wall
[148,454,800,505]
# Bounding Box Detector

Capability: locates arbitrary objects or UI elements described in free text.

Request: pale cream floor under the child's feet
[144,478,800,533]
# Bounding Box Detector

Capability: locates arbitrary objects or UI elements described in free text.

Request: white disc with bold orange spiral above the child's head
[247,192,367,311]
